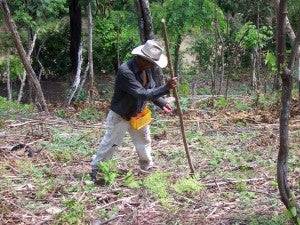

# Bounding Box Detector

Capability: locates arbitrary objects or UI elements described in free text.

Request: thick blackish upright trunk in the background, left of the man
[69,0,81,82]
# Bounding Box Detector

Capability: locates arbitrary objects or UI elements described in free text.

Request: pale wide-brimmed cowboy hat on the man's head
[131,40,168,68]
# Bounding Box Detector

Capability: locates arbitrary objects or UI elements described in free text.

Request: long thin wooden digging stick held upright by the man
[161,19,195,175]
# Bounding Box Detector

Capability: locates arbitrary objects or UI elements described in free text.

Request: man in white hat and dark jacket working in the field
[91,40,177,180]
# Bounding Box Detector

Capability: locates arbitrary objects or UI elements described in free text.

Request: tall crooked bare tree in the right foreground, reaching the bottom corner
[277,0,300,220]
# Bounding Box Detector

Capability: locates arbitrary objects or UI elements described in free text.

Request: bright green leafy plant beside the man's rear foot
[98,160,119,185]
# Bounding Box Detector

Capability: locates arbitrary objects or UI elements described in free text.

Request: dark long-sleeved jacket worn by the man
[110,58,169,120]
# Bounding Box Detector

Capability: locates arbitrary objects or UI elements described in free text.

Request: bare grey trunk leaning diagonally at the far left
[0,0,48,112]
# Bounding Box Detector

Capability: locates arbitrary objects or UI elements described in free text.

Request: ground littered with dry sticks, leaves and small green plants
[0,75,300,225]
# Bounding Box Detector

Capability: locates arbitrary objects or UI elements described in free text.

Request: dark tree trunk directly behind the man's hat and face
[135,0,165,86]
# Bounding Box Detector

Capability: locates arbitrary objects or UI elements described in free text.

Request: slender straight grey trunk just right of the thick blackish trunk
[87,3,94,99]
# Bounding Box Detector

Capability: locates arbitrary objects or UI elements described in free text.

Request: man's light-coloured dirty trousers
[91,110,153,170]
